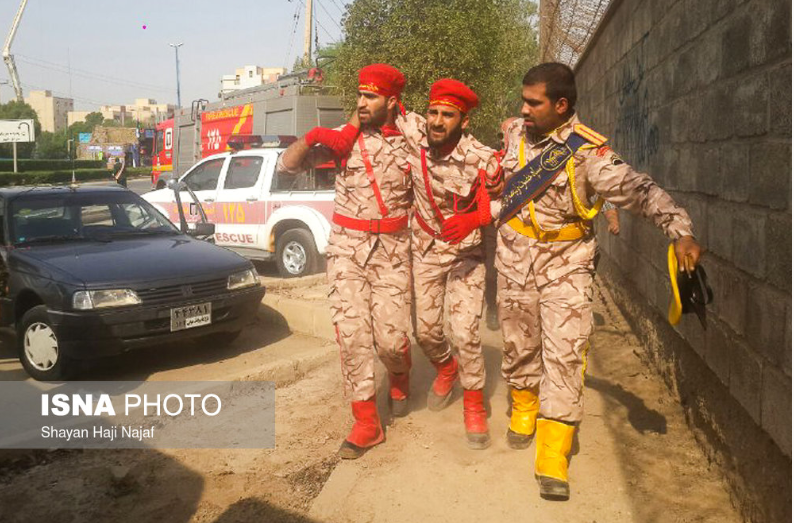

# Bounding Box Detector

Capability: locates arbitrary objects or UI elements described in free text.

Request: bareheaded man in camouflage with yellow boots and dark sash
[492,63,700,499]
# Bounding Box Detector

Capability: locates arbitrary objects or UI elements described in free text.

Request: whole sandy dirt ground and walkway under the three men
[0,280,740,523]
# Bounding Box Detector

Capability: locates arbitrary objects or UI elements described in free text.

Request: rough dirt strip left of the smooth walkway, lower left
[0,336,347,523]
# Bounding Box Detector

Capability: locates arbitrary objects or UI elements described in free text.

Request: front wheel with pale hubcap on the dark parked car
[17,305,72,381]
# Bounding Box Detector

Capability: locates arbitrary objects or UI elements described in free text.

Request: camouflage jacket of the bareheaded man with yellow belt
[491,115,692,285]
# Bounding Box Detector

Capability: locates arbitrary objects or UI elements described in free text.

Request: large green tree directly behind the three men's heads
[331,0,538,144]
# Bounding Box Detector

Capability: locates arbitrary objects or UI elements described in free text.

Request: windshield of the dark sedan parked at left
[9,191,179,244]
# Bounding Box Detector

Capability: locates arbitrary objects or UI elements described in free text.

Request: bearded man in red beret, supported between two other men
[397,79,501,449]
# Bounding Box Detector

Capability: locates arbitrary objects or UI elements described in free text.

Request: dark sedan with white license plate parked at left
[0,187,265,380]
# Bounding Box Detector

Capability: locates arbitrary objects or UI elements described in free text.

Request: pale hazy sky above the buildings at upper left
[0,0,347,110]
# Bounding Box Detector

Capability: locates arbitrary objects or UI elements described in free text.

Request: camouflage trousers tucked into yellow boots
[497,268,593,422]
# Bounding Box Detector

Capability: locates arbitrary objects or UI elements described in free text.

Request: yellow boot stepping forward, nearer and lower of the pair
[535,419,576,501]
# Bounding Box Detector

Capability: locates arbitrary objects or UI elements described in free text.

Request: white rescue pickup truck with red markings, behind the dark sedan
[143,136,337,278]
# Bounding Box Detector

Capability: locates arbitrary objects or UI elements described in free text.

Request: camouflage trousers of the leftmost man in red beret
[327,249,411,401]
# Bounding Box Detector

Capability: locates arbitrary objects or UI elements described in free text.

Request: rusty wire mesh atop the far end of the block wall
[540,0,610,66]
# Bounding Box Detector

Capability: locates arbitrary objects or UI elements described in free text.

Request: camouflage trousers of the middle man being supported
[412,247,485,390]
